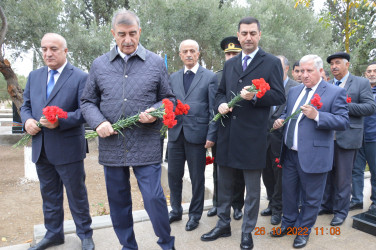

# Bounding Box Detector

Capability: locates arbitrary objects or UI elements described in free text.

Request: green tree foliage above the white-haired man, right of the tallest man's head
[248,0,335,72]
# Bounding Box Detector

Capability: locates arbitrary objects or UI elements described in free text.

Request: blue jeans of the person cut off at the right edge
[351,142,376,204]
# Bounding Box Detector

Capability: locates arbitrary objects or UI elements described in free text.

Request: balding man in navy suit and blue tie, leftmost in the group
[21,33,94,250]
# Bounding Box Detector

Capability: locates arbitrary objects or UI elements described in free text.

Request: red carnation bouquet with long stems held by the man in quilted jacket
[85,99,190,139]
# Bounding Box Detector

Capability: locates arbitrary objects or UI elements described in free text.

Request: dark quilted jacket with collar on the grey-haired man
[81,44,175,167]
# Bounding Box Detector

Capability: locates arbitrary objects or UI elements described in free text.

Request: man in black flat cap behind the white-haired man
[319,52,376,226]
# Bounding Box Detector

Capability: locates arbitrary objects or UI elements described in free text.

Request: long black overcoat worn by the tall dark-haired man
[216,49,286,169]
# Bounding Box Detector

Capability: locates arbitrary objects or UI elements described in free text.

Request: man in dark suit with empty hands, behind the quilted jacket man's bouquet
[168,40,218,231]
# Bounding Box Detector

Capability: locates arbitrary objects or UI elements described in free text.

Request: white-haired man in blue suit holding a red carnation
[270,55,349,248]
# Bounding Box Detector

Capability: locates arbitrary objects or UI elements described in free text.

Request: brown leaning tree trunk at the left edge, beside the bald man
[0,55,23,114]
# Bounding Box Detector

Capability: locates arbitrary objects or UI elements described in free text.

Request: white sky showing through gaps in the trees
[7,0,325,77]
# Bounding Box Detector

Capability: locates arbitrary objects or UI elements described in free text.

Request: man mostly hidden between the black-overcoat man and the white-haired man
[261,55,300,225]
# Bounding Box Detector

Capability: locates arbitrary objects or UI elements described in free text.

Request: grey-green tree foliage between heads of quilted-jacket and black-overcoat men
[129,0,245,72]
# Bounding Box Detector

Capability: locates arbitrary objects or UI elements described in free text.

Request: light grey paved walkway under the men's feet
[0,123,376,250]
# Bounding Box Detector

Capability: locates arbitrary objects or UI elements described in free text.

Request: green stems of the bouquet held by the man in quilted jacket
[85,105,167,139]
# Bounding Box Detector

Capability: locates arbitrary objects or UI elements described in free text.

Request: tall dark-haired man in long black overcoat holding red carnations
[201,17,286,249]
